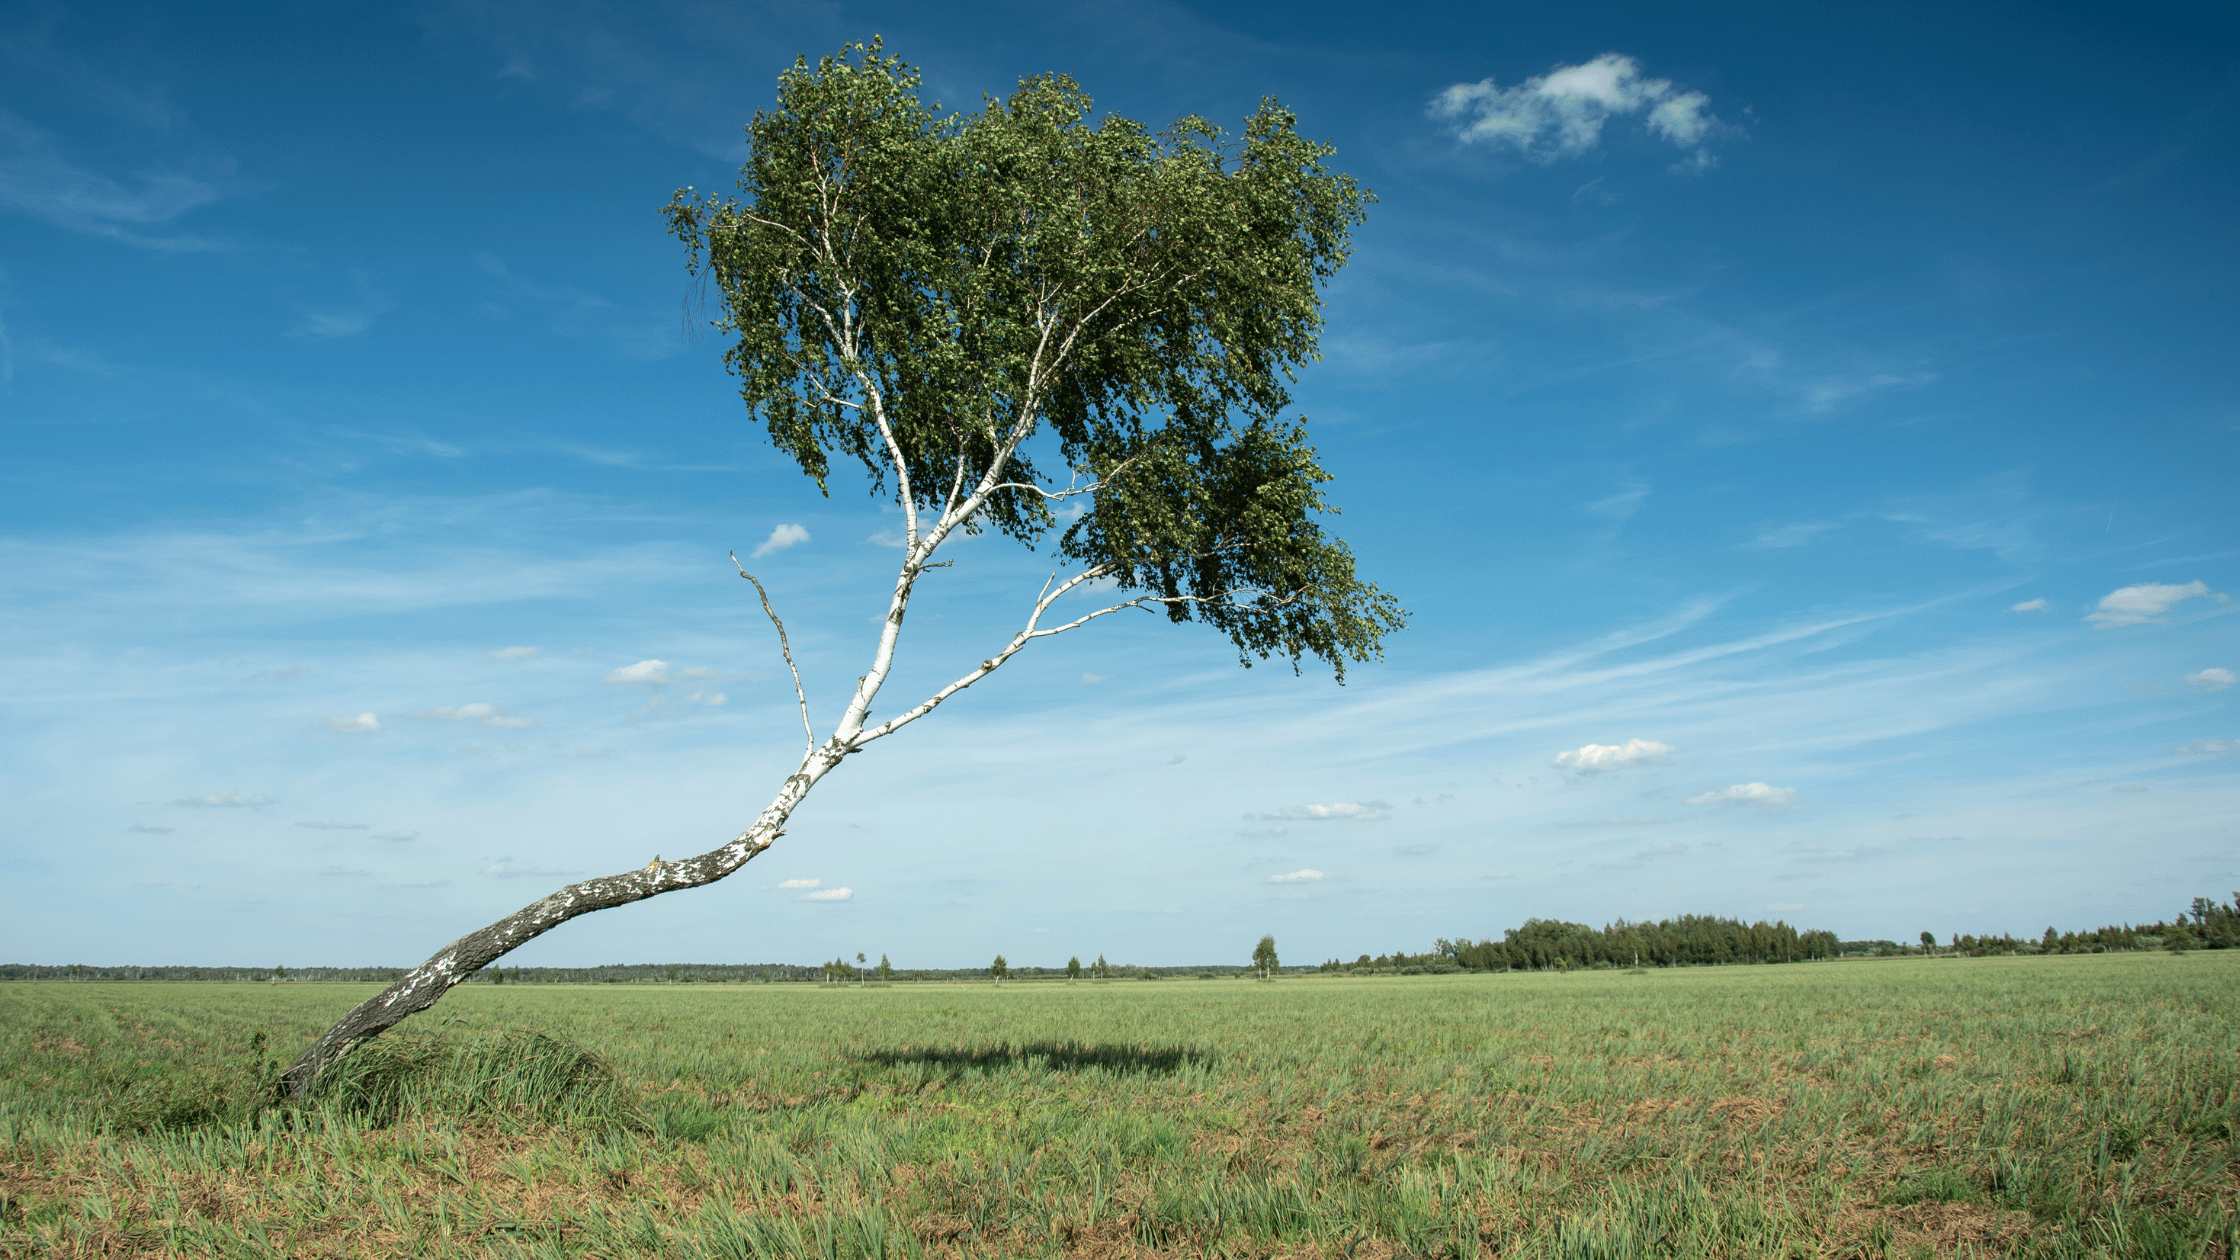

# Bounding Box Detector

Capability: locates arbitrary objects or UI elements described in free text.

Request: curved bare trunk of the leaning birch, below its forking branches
[278,762,824,1099]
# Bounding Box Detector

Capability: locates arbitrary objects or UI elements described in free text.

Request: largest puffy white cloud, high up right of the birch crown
[1429,52,1720,170]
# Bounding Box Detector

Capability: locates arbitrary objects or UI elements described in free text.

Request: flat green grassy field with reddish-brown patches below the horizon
[0,951,2240,1260]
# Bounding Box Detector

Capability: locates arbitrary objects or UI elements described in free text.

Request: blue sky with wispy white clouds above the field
[0,2,2240,966]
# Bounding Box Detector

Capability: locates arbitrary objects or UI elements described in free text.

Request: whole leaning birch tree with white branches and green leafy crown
[282,40,1404,1096]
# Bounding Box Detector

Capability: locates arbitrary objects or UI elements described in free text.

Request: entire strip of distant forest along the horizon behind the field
[0,892,2240,984]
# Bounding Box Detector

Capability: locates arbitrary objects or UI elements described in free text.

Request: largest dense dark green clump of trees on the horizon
[1322,915,1841,975]
